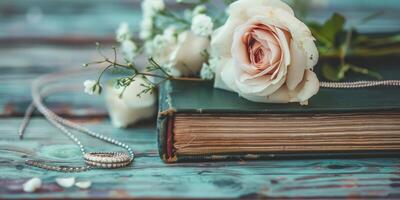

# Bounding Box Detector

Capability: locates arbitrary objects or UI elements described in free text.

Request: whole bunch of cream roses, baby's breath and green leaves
[84,0,400,127]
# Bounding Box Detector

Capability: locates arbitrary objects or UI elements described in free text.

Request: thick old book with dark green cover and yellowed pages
[158,78,400,162]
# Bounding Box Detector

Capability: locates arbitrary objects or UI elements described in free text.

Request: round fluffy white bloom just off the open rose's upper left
[191,14,214,37]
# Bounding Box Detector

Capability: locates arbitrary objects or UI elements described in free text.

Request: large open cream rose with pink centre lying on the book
[211,0,319,104]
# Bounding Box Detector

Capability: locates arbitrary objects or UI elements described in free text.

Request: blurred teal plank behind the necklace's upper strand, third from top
[0,68,107,117]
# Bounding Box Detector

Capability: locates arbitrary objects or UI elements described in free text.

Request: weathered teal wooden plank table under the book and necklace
[0,0,400,199]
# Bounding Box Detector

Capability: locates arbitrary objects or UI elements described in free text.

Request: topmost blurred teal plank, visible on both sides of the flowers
[0,0,400,43]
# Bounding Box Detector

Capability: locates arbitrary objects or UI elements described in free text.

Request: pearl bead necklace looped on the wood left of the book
[19,71,135,173]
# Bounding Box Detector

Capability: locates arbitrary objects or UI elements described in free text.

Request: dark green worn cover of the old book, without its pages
[158,61,400,162]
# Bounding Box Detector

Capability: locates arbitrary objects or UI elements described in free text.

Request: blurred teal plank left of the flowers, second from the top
[0,42,117,68]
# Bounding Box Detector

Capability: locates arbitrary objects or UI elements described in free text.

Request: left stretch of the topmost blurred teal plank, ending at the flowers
[0,0,140,38]
